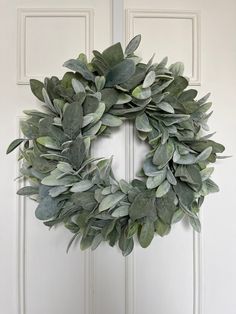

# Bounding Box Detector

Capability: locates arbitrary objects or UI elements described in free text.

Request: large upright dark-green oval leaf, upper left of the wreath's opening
[62,102,83,138]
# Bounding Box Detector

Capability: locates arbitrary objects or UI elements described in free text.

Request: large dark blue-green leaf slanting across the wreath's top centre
[106,59,135,87]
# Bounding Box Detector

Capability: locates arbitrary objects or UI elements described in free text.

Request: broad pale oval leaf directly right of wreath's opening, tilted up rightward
[153,141,175,168]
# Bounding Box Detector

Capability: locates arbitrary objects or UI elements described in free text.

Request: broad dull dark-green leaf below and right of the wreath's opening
[129,190,156,220]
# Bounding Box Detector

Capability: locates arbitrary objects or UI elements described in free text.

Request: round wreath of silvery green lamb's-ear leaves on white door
[7,35,224,255]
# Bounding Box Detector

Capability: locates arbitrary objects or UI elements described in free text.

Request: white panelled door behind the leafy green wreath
[0,0,236,314]
